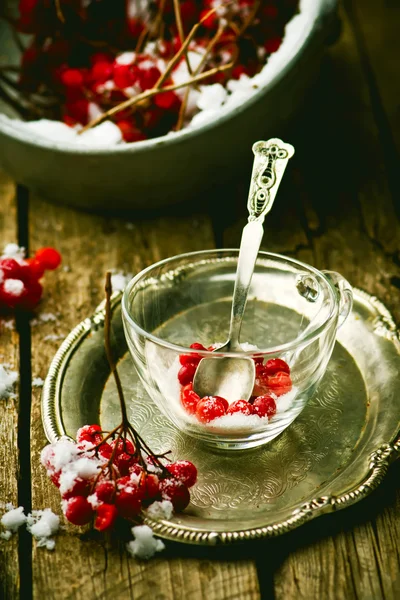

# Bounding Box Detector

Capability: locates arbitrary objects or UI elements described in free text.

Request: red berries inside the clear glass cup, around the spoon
[178,342,292,423]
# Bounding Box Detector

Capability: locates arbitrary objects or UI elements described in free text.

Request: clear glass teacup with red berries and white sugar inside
[122,250,353,449]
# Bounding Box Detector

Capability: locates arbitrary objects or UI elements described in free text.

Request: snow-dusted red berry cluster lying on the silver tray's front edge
[41,425,197,531]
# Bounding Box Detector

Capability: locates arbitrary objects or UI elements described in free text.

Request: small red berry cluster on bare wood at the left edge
[0,248,61,312]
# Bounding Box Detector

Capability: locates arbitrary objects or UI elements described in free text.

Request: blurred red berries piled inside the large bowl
[17,0,298,142]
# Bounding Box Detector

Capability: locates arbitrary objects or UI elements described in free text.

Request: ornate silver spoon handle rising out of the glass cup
[228,138,294,351]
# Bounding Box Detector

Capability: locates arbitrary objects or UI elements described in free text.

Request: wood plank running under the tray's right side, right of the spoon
[224,3,400,600]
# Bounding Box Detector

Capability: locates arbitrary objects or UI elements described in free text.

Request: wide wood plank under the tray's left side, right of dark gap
[30,199,259,600]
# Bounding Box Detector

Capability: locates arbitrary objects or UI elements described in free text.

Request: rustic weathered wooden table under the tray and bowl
[0,0,400,600]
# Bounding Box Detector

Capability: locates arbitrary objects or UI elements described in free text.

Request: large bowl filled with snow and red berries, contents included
[0,0,337,210]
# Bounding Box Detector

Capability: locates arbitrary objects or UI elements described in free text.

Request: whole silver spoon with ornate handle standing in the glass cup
[193,138,294,402]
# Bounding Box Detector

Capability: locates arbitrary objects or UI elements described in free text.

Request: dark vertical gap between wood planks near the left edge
[17,186,33,600]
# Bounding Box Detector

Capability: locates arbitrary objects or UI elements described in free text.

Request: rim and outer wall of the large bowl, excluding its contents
[0,0,337,209]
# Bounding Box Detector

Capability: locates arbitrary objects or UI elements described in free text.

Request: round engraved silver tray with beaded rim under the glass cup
[42,290,400,544]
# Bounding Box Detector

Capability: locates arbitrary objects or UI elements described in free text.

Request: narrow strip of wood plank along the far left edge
[0,172,19,600]
